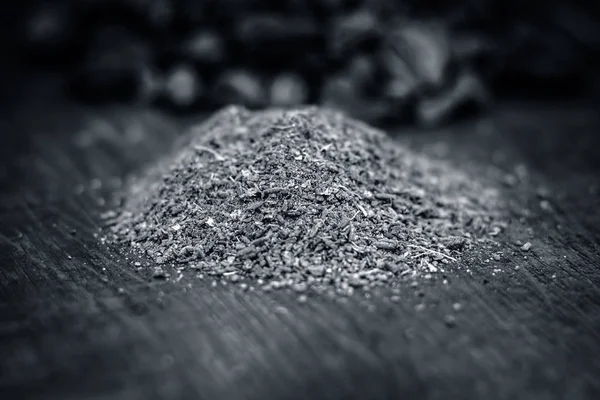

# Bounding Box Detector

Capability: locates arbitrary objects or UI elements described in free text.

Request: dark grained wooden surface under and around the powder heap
[0,83,600,400]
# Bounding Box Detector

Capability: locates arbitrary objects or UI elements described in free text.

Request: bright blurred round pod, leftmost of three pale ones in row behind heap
[164,64,204,109]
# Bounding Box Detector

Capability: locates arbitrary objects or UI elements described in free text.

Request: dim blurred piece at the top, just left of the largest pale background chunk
[327,8,381,59]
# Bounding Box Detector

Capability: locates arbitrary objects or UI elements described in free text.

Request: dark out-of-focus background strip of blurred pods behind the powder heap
[1,0,600,126]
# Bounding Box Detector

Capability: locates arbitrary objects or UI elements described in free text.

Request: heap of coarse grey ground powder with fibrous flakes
[110,107,501,294]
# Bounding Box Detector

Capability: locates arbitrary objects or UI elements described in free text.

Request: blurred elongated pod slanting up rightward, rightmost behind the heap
[416,71,490,127]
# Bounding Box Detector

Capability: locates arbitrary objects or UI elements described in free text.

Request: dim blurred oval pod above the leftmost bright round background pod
[182,30,227,66]
